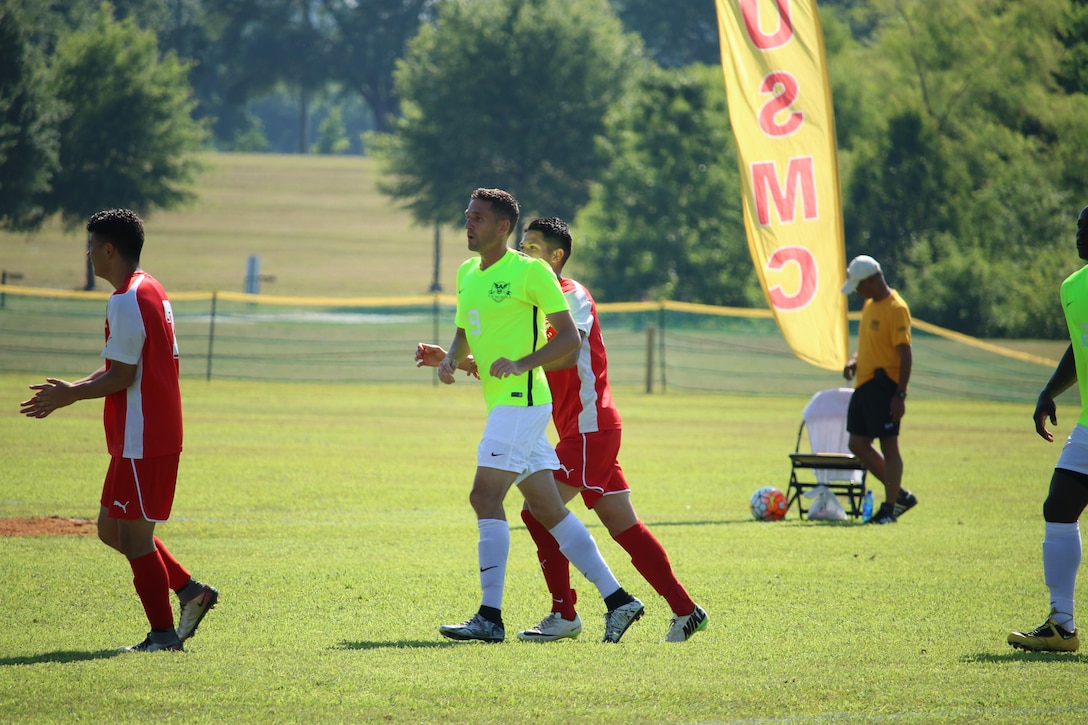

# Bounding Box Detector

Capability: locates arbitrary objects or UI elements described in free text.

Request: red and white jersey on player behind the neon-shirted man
[547,278,621,438]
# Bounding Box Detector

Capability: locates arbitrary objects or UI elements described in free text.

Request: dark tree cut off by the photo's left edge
[0,0,59,230]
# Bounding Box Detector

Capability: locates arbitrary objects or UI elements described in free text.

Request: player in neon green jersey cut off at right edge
[1009,201,1088,652]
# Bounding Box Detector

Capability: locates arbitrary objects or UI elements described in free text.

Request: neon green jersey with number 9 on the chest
[457,249,569,410]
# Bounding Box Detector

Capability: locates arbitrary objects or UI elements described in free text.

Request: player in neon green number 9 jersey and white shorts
[438,188,643,642]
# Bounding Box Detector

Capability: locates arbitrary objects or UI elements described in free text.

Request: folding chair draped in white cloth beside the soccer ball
[786,388,868,518]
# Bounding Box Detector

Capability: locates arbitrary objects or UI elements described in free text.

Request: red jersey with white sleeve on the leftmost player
[102,271,182,458]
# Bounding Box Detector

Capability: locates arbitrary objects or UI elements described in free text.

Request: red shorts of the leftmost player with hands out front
[101,454,181,523]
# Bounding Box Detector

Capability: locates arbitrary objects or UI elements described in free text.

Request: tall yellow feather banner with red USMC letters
[716,0,850,370]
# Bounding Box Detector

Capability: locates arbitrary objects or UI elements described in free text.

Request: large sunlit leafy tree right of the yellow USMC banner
[844,0,1088,335]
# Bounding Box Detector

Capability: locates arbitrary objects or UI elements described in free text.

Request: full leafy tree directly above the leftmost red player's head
[39,3,205,286]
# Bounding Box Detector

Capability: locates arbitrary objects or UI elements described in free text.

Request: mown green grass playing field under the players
[0,374,1088,723]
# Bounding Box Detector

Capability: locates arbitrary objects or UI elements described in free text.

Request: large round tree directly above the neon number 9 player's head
[367,0,643,223]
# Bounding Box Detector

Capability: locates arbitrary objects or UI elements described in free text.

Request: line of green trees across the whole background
[0,0,1088,337]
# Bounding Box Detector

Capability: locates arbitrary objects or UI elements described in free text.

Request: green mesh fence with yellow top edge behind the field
[0,285,1056,402]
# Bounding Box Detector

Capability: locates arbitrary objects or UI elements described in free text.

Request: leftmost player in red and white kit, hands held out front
[20,209,219,652]
